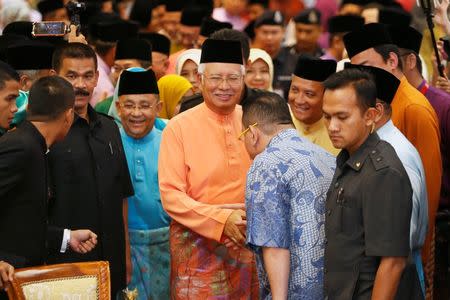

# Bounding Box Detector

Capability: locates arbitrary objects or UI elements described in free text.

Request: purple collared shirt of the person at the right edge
[417,80,450,207]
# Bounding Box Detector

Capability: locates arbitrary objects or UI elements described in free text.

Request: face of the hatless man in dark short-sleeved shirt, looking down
[323,86,377,154]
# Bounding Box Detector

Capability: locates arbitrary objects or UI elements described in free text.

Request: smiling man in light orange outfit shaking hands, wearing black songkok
[158,39,258,299]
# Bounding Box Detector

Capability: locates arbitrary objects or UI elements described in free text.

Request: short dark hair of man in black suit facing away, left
[27,76,75,121]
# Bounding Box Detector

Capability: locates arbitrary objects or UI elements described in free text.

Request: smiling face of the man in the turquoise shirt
[116,94,161,139]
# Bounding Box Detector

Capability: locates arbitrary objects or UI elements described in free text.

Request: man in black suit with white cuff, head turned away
[0,76,97,298]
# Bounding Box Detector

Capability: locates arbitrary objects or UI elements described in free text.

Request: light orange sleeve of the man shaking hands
[158,123,233,241]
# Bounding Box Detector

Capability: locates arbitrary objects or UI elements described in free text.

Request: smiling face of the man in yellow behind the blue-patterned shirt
[288,75,324,125]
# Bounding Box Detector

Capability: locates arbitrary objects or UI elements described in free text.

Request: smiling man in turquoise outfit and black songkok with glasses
[115,70,170,299]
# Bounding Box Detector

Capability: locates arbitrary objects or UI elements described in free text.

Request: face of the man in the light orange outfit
[201,63,244,115]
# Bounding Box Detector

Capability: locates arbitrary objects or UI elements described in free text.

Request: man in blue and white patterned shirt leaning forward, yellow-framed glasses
[241,92,335,300]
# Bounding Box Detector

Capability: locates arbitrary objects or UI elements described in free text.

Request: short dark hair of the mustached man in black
[52,43,97,71]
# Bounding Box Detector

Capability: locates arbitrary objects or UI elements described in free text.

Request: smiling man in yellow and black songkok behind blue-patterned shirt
[288,55,339,156]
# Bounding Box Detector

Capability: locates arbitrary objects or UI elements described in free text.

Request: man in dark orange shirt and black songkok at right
[344,23,442,298]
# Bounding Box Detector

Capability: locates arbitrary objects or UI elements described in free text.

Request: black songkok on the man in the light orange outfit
[200,39,243,65]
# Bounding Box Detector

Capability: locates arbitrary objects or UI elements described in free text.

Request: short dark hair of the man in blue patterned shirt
[242,91,294,134]
